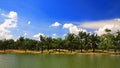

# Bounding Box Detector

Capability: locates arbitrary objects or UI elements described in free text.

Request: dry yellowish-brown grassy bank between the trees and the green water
[0,50,120,54]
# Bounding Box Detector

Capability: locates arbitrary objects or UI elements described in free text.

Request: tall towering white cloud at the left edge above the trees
[0,11,18,39]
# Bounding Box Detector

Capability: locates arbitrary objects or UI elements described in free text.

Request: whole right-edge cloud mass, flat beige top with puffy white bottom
[79,18,120,35]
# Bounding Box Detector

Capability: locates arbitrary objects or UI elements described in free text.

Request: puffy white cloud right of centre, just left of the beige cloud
[63,23,86,34]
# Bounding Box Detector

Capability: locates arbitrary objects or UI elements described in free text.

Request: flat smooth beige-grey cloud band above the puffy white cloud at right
[79,18,120,29]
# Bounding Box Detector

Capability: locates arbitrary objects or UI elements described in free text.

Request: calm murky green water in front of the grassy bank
[0,54,120,68]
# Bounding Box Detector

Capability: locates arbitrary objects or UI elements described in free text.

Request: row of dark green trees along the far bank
[0,29,120,53]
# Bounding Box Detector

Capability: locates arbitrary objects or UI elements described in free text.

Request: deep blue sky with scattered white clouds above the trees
[0,0,120,39]
